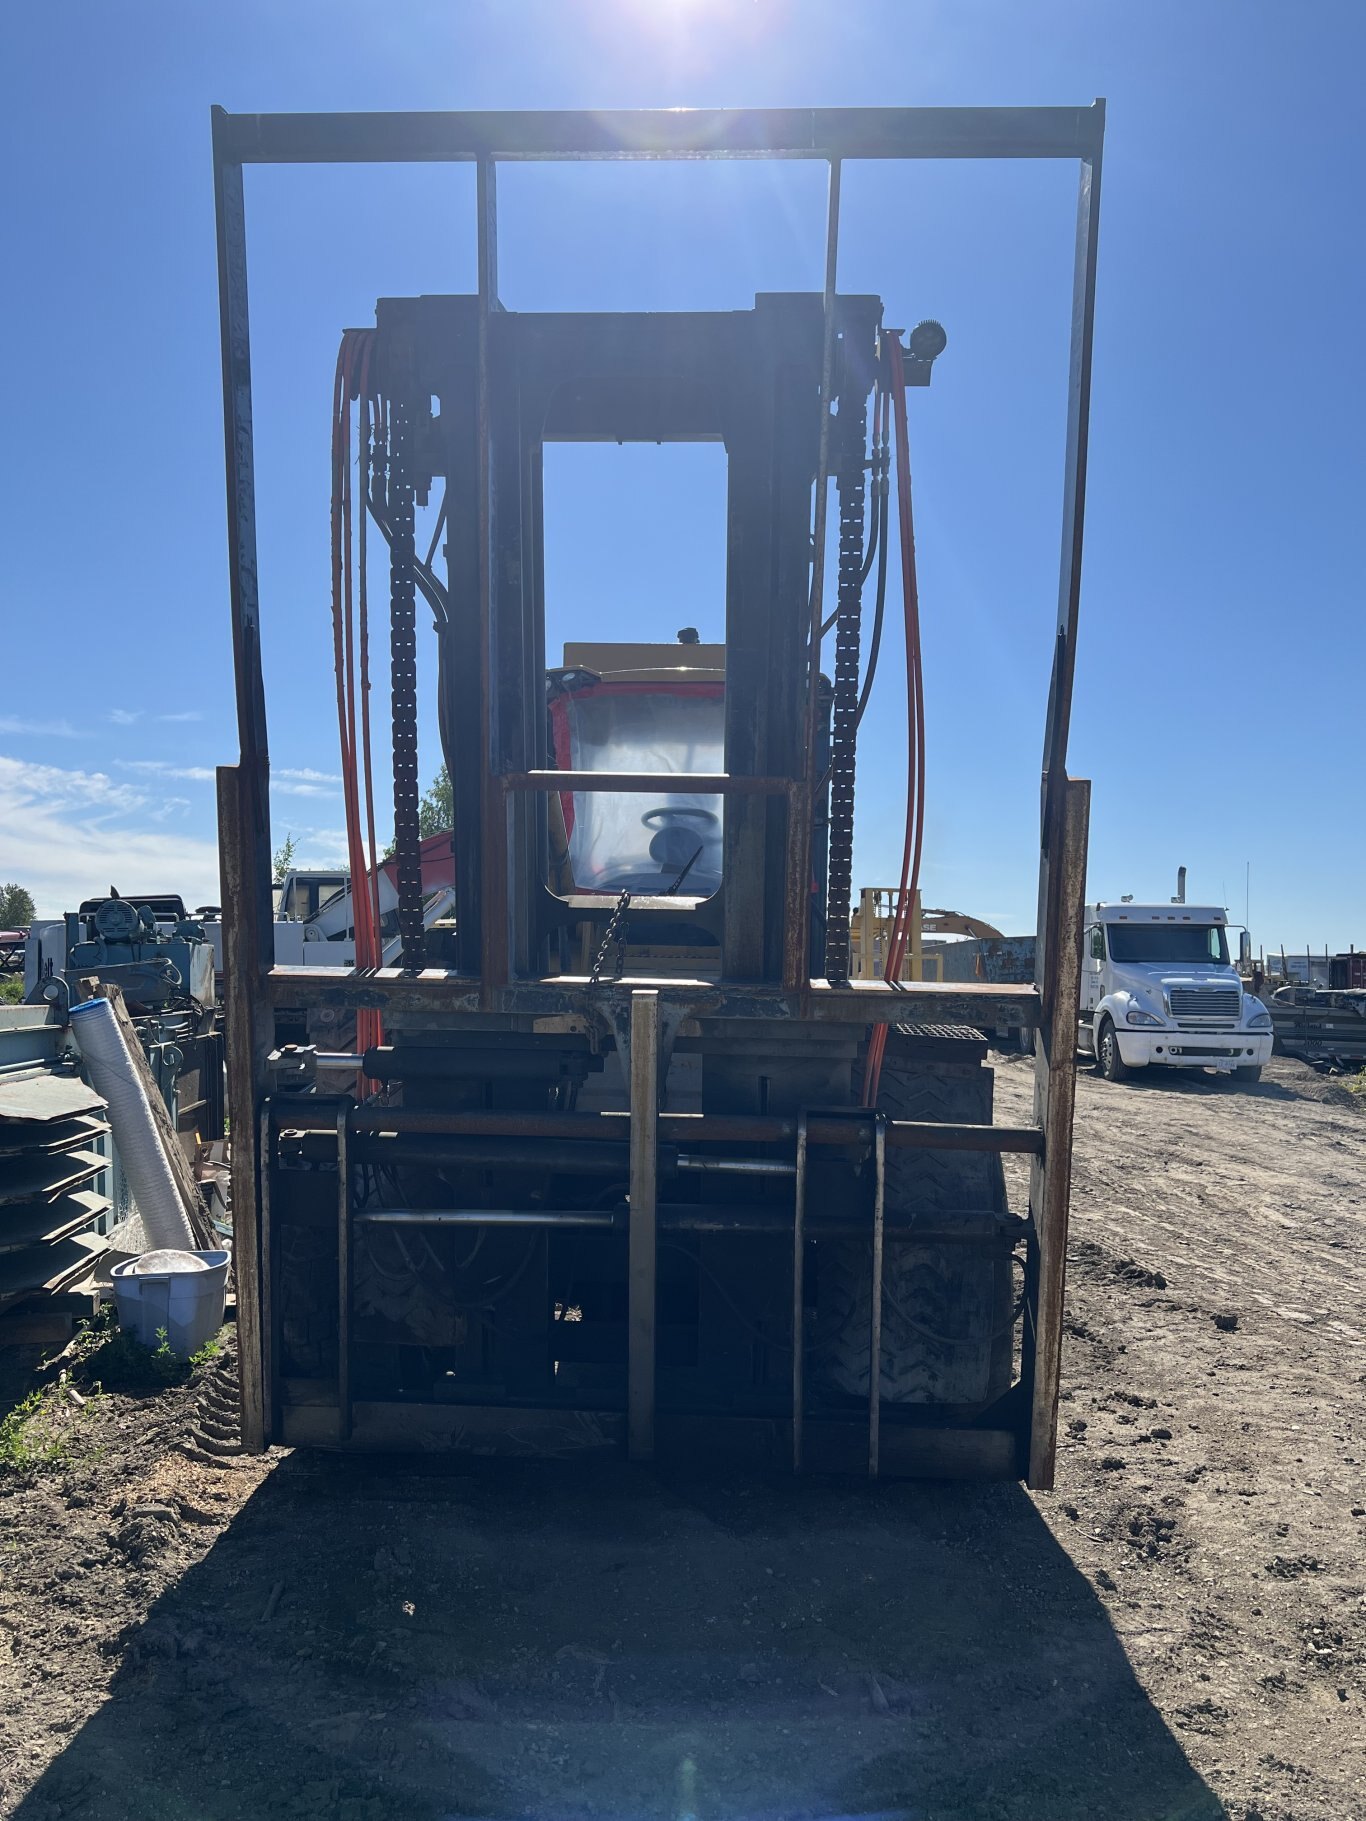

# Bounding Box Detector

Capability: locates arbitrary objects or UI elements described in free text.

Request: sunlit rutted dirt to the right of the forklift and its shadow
[996,1058,1366,1821]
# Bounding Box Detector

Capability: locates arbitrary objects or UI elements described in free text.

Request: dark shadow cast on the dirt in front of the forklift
[15,1455,1224,1821]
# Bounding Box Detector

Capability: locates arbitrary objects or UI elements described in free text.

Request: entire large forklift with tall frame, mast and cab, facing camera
[213,102,1104,1488]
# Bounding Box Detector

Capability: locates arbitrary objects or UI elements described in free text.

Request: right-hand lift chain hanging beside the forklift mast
[818,399,869,985]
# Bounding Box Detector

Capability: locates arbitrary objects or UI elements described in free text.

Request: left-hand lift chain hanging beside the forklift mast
[388,397,426,967]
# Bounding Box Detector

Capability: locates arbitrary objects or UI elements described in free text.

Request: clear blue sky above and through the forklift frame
[0,0,1366,949]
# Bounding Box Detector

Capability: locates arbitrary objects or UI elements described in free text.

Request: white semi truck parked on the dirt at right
[1078,901,1273,1082]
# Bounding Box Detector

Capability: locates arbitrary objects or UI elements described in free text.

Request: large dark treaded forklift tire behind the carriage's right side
[812,1034,1013,1404]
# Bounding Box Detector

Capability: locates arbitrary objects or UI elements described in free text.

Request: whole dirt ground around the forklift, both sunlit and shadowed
[0,1058,1366,1821]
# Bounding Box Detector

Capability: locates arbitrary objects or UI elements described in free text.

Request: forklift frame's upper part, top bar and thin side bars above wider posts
[213,100,1106,1014]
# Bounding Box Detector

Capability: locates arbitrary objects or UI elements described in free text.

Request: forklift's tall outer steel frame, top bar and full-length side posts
[213,100,1106,1486]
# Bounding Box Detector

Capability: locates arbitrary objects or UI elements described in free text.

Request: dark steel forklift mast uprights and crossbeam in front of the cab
[375,295,882,985]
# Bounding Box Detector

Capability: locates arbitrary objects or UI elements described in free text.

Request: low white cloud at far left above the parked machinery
[0,756,219,918]
